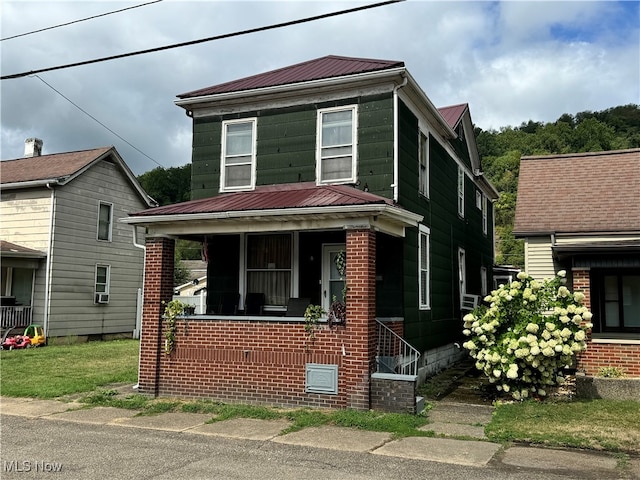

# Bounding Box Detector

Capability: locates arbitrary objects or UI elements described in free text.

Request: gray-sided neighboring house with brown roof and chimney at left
[0,139,155,338]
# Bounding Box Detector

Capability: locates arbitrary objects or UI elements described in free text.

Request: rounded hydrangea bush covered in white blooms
[462,271,593,400]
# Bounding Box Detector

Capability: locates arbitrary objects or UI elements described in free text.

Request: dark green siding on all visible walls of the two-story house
[192,93,493,351]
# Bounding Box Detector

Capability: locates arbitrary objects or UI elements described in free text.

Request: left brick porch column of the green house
[138,237,175,395]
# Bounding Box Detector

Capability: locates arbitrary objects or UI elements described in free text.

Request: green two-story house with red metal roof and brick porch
[126,56,498,411]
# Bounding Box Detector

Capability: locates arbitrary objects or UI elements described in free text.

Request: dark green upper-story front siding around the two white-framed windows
[191,94,393,199]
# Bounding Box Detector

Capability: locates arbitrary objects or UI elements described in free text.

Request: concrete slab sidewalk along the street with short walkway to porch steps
[0,397,640,480]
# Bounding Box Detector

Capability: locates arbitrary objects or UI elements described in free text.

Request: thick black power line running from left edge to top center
[0,0,405,80]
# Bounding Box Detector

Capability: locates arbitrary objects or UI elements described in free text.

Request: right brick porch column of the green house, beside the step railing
[344,229,376,410]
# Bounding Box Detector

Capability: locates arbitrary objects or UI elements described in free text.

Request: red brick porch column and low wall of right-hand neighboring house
[572,268,640,377]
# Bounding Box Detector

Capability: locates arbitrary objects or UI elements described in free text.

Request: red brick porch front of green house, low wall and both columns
[139,229,376,409]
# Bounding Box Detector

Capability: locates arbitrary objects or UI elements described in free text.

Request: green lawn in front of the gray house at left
[0,340,139,398]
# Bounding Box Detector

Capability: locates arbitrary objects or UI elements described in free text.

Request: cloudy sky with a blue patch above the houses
[0,0,640,175]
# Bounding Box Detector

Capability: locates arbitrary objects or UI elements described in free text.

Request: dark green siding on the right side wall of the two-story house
[398,102,493,351]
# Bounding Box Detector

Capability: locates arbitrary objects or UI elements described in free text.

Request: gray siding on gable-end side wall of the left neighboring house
[47,161,146,336]
